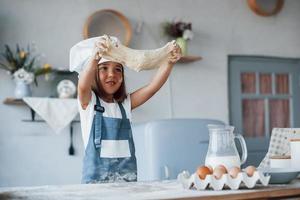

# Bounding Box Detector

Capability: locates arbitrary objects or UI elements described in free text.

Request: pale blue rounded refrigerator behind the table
[132,119,224,181]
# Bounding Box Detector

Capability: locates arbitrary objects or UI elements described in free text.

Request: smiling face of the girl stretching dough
[98,61,123,95]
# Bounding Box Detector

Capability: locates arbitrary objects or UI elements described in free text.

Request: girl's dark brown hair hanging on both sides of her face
[92,65,127,103]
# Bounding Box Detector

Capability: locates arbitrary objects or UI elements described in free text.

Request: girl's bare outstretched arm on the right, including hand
[130,46,181,110]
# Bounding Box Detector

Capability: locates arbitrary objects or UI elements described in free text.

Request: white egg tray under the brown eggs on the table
[177,171,271,190]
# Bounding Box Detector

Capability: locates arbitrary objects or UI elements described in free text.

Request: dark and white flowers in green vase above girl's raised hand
[163,21,193,40]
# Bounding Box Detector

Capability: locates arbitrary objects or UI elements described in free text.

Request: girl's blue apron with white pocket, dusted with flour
[82,96,137,183]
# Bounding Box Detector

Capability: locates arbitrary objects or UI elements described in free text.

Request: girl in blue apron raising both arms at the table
[78,36,181,183]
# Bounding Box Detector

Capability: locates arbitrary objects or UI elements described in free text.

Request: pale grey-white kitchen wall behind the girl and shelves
[0,0,300,186]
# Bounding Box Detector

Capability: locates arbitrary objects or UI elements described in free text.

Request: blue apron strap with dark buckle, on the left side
[94,95,104,148]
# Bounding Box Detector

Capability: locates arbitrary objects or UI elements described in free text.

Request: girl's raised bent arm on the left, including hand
[77,40,107,110]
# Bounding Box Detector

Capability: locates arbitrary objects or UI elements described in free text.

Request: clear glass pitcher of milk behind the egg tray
[205,124,247,170]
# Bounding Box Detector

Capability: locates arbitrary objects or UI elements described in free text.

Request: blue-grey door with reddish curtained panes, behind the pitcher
[228,56,300,165]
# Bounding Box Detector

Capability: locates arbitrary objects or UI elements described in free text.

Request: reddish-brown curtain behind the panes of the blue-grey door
[241,72,290,137]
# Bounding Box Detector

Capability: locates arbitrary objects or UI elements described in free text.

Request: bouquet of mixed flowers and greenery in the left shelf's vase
[0,44,53,85]
